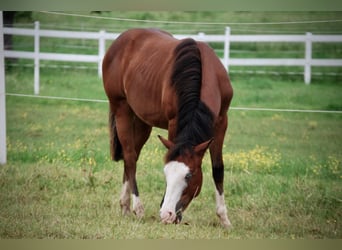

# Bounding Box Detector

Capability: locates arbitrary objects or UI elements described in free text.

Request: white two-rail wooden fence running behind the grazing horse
[3,22,342,94]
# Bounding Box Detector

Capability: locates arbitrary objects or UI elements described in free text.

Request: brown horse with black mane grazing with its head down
[102,29,233,227]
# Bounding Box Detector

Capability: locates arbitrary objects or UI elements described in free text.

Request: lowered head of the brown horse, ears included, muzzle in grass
[159,136,212,223]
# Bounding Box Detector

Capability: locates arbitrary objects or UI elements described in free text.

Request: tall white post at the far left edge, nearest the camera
[0,11,7,164]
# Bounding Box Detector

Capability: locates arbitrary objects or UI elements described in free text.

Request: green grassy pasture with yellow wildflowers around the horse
[0,13,342,239]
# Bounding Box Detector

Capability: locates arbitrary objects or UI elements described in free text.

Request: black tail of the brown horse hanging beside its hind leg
[109,108,123,161]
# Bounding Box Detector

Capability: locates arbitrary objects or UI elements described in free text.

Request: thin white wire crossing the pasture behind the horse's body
[6,93,342,114]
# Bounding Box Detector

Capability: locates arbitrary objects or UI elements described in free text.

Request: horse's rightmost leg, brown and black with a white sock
[210,116,231,228]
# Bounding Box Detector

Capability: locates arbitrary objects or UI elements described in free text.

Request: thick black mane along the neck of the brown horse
[168,38,214,160]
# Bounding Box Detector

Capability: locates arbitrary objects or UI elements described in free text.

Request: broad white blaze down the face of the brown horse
[160,161,190,223]
